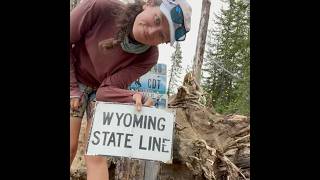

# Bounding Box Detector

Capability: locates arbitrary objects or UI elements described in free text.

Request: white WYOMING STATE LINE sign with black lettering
[87,102,175,163]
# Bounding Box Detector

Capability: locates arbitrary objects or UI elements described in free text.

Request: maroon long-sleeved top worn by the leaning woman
[70,0,159,103]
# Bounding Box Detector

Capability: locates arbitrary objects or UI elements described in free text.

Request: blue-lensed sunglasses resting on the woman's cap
[170,5,188,41]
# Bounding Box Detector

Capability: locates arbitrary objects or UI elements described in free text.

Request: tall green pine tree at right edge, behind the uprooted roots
[203,0,250,115]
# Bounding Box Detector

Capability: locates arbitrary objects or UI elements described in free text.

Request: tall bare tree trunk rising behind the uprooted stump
[192,0,211,85]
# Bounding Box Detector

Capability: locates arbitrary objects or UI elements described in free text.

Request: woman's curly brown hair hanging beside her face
[99,0,162,51]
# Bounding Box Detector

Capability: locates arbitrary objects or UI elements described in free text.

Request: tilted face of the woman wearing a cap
[132,5,170,46]
